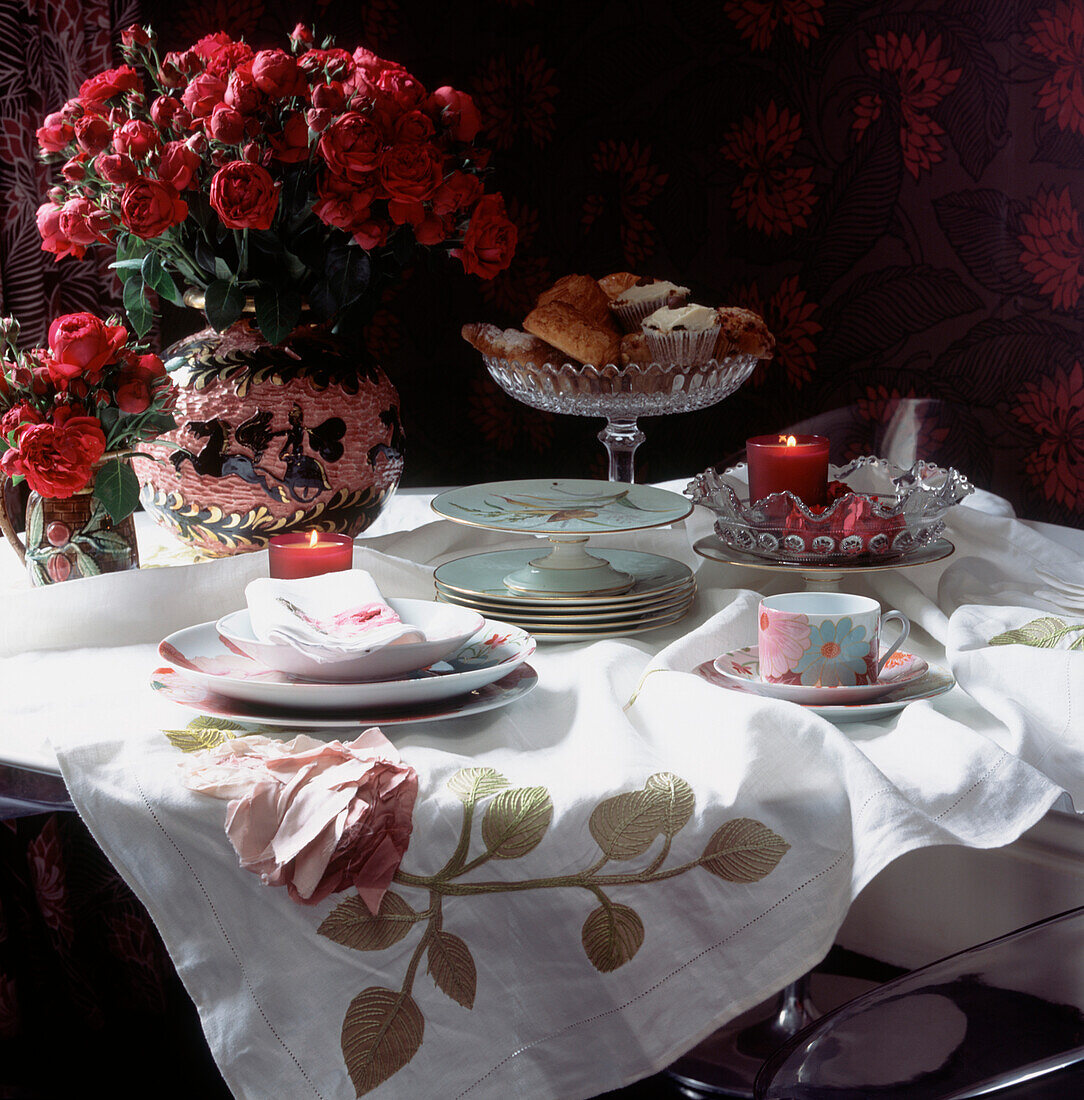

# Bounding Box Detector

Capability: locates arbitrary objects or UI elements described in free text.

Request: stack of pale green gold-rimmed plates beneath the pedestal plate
[434,547,697,641]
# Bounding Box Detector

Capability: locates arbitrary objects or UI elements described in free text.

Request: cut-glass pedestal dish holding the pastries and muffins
[482,354,757,482]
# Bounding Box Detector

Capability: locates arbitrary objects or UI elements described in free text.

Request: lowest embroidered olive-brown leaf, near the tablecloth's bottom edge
[342,986,425,1097]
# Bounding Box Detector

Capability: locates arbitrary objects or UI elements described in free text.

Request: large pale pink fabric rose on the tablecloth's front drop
[185,726,418,915]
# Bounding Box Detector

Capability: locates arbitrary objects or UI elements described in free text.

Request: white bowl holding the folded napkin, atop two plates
[215,600,485,683]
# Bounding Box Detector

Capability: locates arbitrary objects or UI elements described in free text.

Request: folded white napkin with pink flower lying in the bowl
[244,569,425,662]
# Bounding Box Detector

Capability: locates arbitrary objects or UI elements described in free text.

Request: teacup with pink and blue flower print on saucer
[757,592,911,688]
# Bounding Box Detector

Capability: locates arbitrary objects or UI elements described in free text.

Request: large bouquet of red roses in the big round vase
[37,24,516,343]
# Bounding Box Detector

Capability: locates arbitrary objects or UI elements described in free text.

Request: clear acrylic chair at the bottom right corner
[754,906,1084,1100]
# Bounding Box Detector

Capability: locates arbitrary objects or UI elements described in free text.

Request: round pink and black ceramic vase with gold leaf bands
[133,316,403,556]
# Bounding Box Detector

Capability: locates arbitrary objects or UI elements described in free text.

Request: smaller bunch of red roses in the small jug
[0,305,177,524]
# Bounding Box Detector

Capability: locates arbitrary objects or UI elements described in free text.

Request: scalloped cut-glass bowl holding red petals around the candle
[686,455,974,563]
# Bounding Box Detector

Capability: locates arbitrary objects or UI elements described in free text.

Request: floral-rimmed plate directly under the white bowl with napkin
[158,619,535,714]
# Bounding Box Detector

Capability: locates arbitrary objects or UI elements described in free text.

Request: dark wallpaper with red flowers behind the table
[0,0,1084,526]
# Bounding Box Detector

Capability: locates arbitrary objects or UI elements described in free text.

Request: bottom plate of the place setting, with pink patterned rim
[151,664,538,729]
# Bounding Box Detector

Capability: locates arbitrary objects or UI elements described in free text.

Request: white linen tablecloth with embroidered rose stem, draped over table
[0,483,1084,1100]
